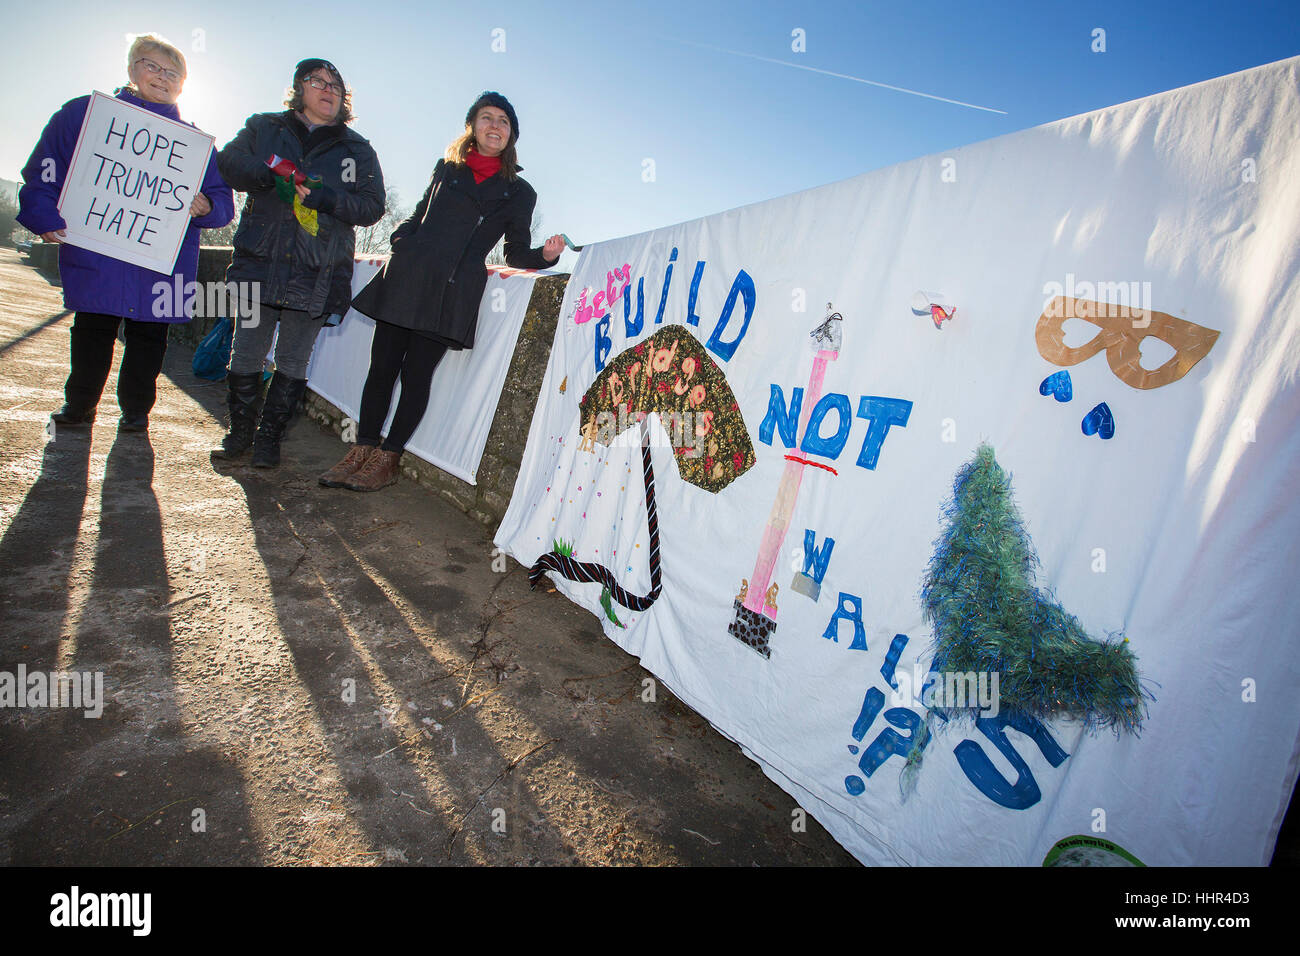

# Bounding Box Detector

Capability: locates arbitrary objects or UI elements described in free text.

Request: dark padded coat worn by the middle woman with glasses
[217,111,384,316]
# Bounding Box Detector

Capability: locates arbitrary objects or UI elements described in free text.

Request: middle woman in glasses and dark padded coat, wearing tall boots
[213,57,384,468]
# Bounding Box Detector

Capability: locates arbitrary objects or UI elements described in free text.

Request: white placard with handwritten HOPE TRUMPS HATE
[59,91,212,273]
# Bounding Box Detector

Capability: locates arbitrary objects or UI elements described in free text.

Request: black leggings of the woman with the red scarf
[356,321,447,451]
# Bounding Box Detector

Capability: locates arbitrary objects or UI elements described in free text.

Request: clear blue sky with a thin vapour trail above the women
[0,0,1300,265]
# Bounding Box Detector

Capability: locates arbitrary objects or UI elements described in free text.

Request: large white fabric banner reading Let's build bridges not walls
[497,57,1300,865]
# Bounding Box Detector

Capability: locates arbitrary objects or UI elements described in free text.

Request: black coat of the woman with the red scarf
[352,160,554,349]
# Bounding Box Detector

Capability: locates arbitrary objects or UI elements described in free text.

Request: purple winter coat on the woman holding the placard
[18,90,234,323]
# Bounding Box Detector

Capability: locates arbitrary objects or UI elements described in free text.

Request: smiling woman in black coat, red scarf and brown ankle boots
[320,92,564,492]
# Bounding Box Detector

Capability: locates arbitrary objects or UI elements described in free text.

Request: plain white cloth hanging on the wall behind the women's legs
[307,259,558,484]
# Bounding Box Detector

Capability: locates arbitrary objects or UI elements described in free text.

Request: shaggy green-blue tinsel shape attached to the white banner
[917,445,1144,733]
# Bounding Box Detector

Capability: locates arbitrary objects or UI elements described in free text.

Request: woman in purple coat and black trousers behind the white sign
[18,34,234,432]
